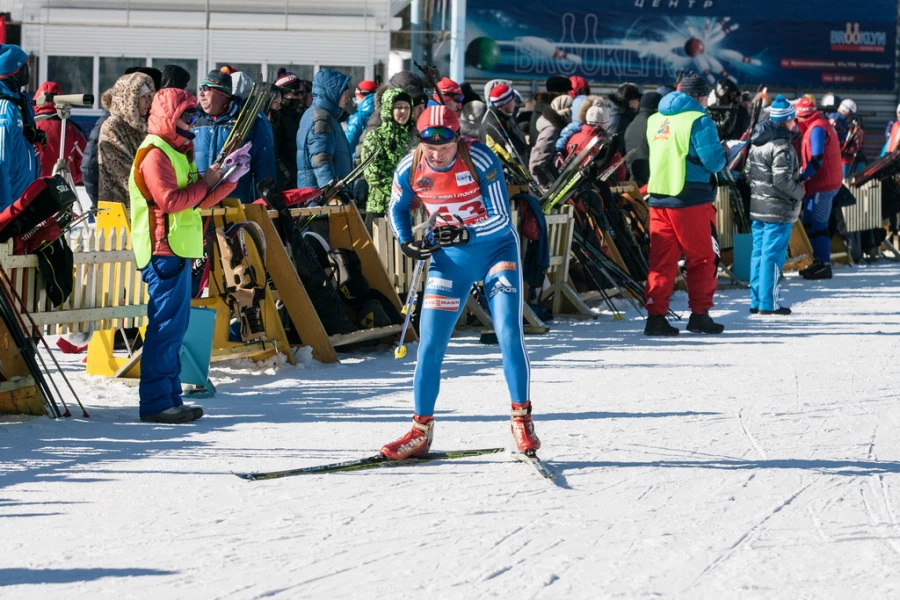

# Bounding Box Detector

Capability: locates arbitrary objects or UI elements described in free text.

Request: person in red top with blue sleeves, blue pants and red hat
[795,96,844,279]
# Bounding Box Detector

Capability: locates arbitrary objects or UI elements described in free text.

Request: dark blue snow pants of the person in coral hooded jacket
[140,256,191,416]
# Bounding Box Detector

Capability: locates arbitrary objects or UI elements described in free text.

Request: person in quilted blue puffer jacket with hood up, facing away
[297,69,353,189]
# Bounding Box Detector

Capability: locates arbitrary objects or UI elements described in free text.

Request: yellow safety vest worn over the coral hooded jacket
[128,134,203,269]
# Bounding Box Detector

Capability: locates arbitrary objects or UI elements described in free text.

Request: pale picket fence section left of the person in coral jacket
[0,228,148,335]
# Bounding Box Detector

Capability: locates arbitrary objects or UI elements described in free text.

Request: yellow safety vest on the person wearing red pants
[647,111,705,196]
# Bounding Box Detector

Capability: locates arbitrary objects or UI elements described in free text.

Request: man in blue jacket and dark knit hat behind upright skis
[191,71,275,204]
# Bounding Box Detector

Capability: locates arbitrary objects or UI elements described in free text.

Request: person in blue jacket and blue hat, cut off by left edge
[0,44,43,211]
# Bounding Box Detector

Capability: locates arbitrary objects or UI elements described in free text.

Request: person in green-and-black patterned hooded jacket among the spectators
[361,88,412,220]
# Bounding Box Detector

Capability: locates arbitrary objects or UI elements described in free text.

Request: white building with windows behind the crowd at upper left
[0,0,409,108]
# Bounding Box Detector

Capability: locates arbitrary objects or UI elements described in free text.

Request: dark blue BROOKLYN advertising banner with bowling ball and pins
[466,0,897,91]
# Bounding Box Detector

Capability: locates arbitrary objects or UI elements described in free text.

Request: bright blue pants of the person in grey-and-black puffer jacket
[750,221,794,310]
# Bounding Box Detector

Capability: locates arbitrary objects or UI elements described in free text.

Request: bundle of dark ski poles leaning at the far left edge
[0,266,90,418]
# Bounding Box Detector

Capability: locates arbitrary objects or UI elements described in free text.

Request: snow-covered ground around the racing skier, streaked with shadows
[0,263,900,600]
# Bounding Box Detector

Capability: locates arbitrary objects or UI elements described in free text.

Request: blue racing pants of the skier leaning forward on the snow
[414,231,530,417]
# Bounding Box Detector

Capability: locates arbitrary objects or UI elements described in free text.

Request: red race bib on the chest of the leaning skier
[412,156,488,225]
